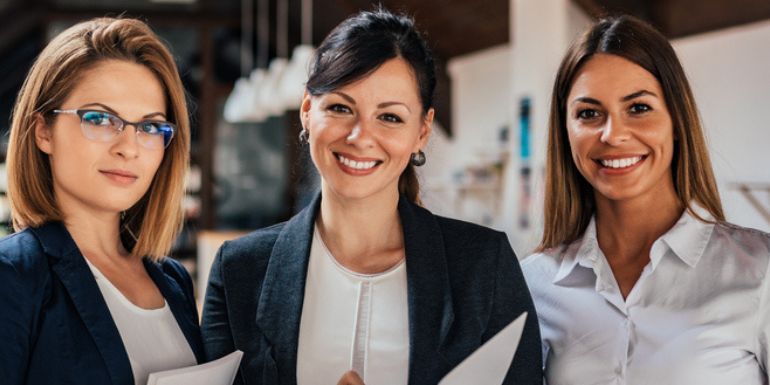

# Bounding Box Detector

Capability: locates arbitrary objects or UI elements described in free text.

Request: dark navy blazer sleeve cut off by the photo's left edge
[0,250,42,385]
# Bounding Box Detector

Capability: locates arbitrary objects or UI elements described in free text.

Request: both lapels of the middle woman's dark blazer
[256,194,454,383]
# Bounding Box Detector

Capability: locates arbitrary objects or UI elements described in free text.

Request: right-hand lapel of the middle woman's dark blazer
[398,196,454,384]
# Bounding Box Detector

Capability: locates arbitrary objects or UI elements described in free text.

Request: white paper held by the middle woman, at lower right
[439,312,527,385]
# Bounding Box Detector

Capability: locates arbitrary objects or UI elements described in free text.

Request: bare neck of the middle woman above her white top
[317,182,404,272]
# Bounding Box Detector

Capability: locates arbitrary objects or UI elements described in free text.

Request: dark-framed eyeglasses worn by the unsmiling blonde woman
[53,110,176,150]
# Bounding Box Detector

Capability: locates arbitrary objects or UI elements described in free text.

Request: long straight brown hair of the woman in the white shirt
[537,16,725,251]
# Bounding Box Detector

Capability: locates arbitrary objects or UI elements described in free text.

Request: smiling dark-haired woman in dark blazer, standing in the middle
[202,10,542,385]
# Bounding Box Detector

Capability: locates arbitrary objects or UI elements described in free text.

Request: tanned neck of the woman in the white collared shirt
[596,185,684,260]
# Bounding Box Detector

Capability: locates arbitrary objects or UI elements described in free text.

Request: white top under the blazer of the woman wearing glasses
[86,259,197,385]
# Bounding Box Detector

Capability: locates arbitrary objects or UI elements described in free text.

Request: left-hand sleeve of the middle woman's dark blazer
[201,243,235,361]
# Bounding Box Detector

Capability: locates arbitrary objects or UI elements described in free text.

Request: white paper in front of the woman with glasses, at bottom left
[147,350,243,385]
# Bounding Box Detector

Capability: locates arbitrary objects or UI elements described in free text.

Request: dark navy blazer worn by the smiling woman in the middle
[201,196,542,385]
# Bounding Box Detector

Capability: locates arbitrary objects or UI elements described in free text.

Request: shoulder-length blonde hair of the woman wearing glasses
[6,18,190,259]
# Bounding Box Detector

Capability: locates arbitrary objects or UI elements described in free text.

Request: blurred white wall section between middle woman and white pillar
[419,45,511,227]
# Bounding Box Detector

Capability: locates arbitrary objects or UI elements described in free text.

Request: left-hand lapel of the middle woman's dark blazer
[257,194,321,384]
